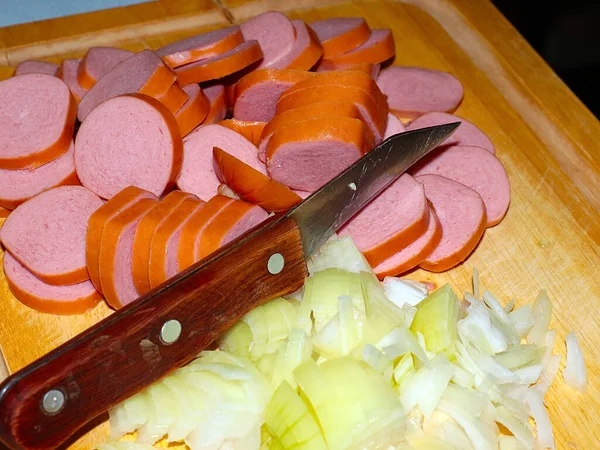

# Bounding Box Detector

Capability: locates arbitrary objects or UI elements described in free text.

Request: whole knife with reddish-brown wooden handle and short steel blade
[0,123,459,450]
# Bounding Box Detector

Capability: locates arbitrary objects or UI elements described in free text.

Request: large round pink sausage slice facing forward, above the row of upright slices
[75,94,183,199]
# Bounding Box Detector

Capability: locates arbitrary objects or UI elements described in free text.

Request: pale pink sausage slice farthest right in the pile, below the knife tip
[411,146,510,227]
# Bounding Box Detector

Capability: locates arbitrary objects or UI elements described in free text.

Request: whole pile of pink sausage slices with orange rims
[0,11,510,314]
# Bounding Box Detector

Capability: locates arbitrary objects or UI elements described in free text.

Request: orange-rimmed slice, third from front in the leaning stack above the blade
[276,85,388,144]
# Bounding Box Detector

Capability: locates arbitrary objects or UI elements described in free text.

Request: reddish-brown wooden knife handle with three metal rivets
[0,216,307,450]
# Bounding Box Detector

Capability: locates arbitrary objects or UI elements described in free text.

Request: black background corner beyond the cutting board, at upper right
[492,0,600,117]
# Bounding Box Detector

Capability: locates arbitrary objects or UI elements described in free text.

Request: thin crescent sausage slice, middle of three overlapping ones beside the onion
[373,208,442,278]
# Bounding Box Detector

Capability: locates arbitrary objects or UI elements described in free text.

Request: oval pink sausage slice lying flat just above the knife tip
[377,66,464,118]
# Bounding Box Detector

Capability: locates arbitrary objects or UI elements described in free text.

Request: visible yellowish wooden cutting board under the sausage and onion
[0,0,600,449]
